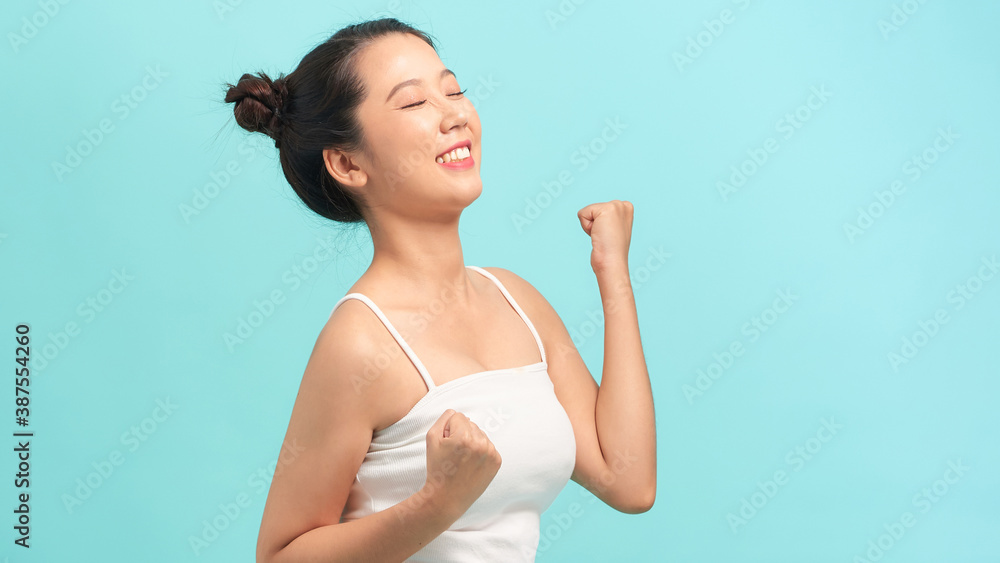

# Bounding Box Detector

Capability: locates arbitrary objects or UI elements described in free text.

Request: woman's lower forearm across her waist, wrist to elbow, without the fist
[267,487,461,563]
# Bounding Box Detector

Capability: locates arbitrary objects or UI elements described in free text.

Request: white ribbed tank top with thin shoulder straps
[331,266,576,563]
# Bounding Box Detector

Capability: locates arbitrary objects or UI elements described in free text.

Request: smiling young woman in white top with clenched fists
[225,19,656,563]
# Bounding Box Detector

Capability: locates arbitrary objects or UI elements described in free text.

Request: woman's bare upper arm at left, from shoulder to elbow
[257,299,404,561]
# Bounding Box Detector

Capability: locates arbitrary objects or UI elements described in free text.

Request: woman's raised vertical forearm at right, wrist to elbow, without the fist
[596,262,656,504]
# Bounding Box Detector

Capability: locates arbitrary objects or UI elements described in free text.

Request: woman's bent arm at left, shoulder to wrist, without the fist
[257,302,462,563]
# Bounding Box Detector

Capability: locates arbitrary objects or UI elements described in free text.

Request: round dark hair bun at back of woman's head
[226,72,288,147]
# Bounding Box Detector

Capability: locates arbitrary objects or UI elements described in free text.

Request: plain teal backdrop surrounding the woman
[0,0,1000,563]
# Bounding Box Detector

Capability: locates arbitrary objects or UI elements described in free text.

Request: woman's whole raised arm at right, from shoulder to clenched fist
[491,200,656,514]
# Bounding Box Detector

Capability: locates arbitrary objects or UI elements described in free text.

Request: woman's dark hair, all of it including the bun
[225,18,437,223]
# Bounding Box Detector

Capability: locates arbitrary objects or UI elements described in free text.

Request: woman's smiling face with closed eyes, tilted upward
[346,33,482,218]
